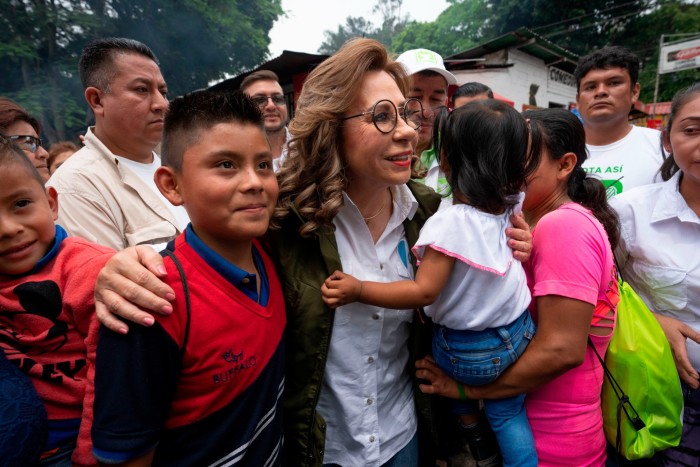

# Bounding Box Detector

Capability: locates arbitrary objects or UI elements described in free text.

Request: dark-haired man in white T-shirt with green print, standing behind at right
[574,46,664,198]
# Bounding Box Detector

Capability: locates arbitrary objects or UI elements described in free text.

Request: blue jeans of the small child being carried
[433,311,537,467]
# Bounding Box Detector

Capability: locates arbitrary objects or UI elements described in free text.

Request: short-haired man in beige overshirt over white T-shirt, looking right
[47,38,189,250]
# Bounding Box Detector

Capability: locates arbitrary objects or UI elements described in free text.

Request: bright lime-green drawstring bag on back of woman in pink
[602,280,683,460]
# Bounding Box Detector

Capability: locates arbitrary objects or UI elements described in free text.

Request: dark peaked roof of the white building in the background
[445,27,579,73]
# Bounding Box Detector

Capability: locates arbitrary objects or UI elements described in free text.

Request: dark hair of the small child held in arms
[434,100,537,214]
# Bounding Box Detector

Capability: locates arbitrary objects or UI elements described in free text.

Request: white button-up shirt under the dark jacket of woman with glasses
[318,185,418,467]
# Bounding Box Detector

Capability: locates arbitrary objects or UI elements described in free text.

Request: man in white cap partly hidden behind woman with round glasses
[396,49,457,204]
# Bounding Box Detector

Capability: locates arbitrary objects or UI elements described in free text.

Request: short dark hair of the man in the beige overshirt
[79,37,158,91]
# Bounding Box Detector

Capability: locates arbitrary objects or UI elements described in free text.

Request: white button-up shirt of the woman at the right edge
[610,172,700,370]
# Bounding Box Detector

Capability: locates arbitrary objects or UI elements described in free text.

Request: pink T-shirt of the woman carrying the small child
[525,203,619,466]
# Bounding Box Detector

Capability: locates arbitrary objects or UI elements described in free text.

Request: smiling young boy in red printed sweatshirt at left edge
[0,137,114,465]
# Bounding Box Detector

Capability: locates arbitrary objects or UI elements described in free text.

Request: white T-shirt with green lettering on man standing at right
[583,125,664,199]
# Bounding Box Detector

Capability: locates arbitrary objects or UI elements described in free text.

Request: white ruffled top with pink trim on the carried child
[413,197,530,331]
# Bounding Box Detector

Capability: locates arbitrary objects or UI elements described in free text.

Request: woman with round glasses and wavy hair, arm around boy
[90,39,531,467]
